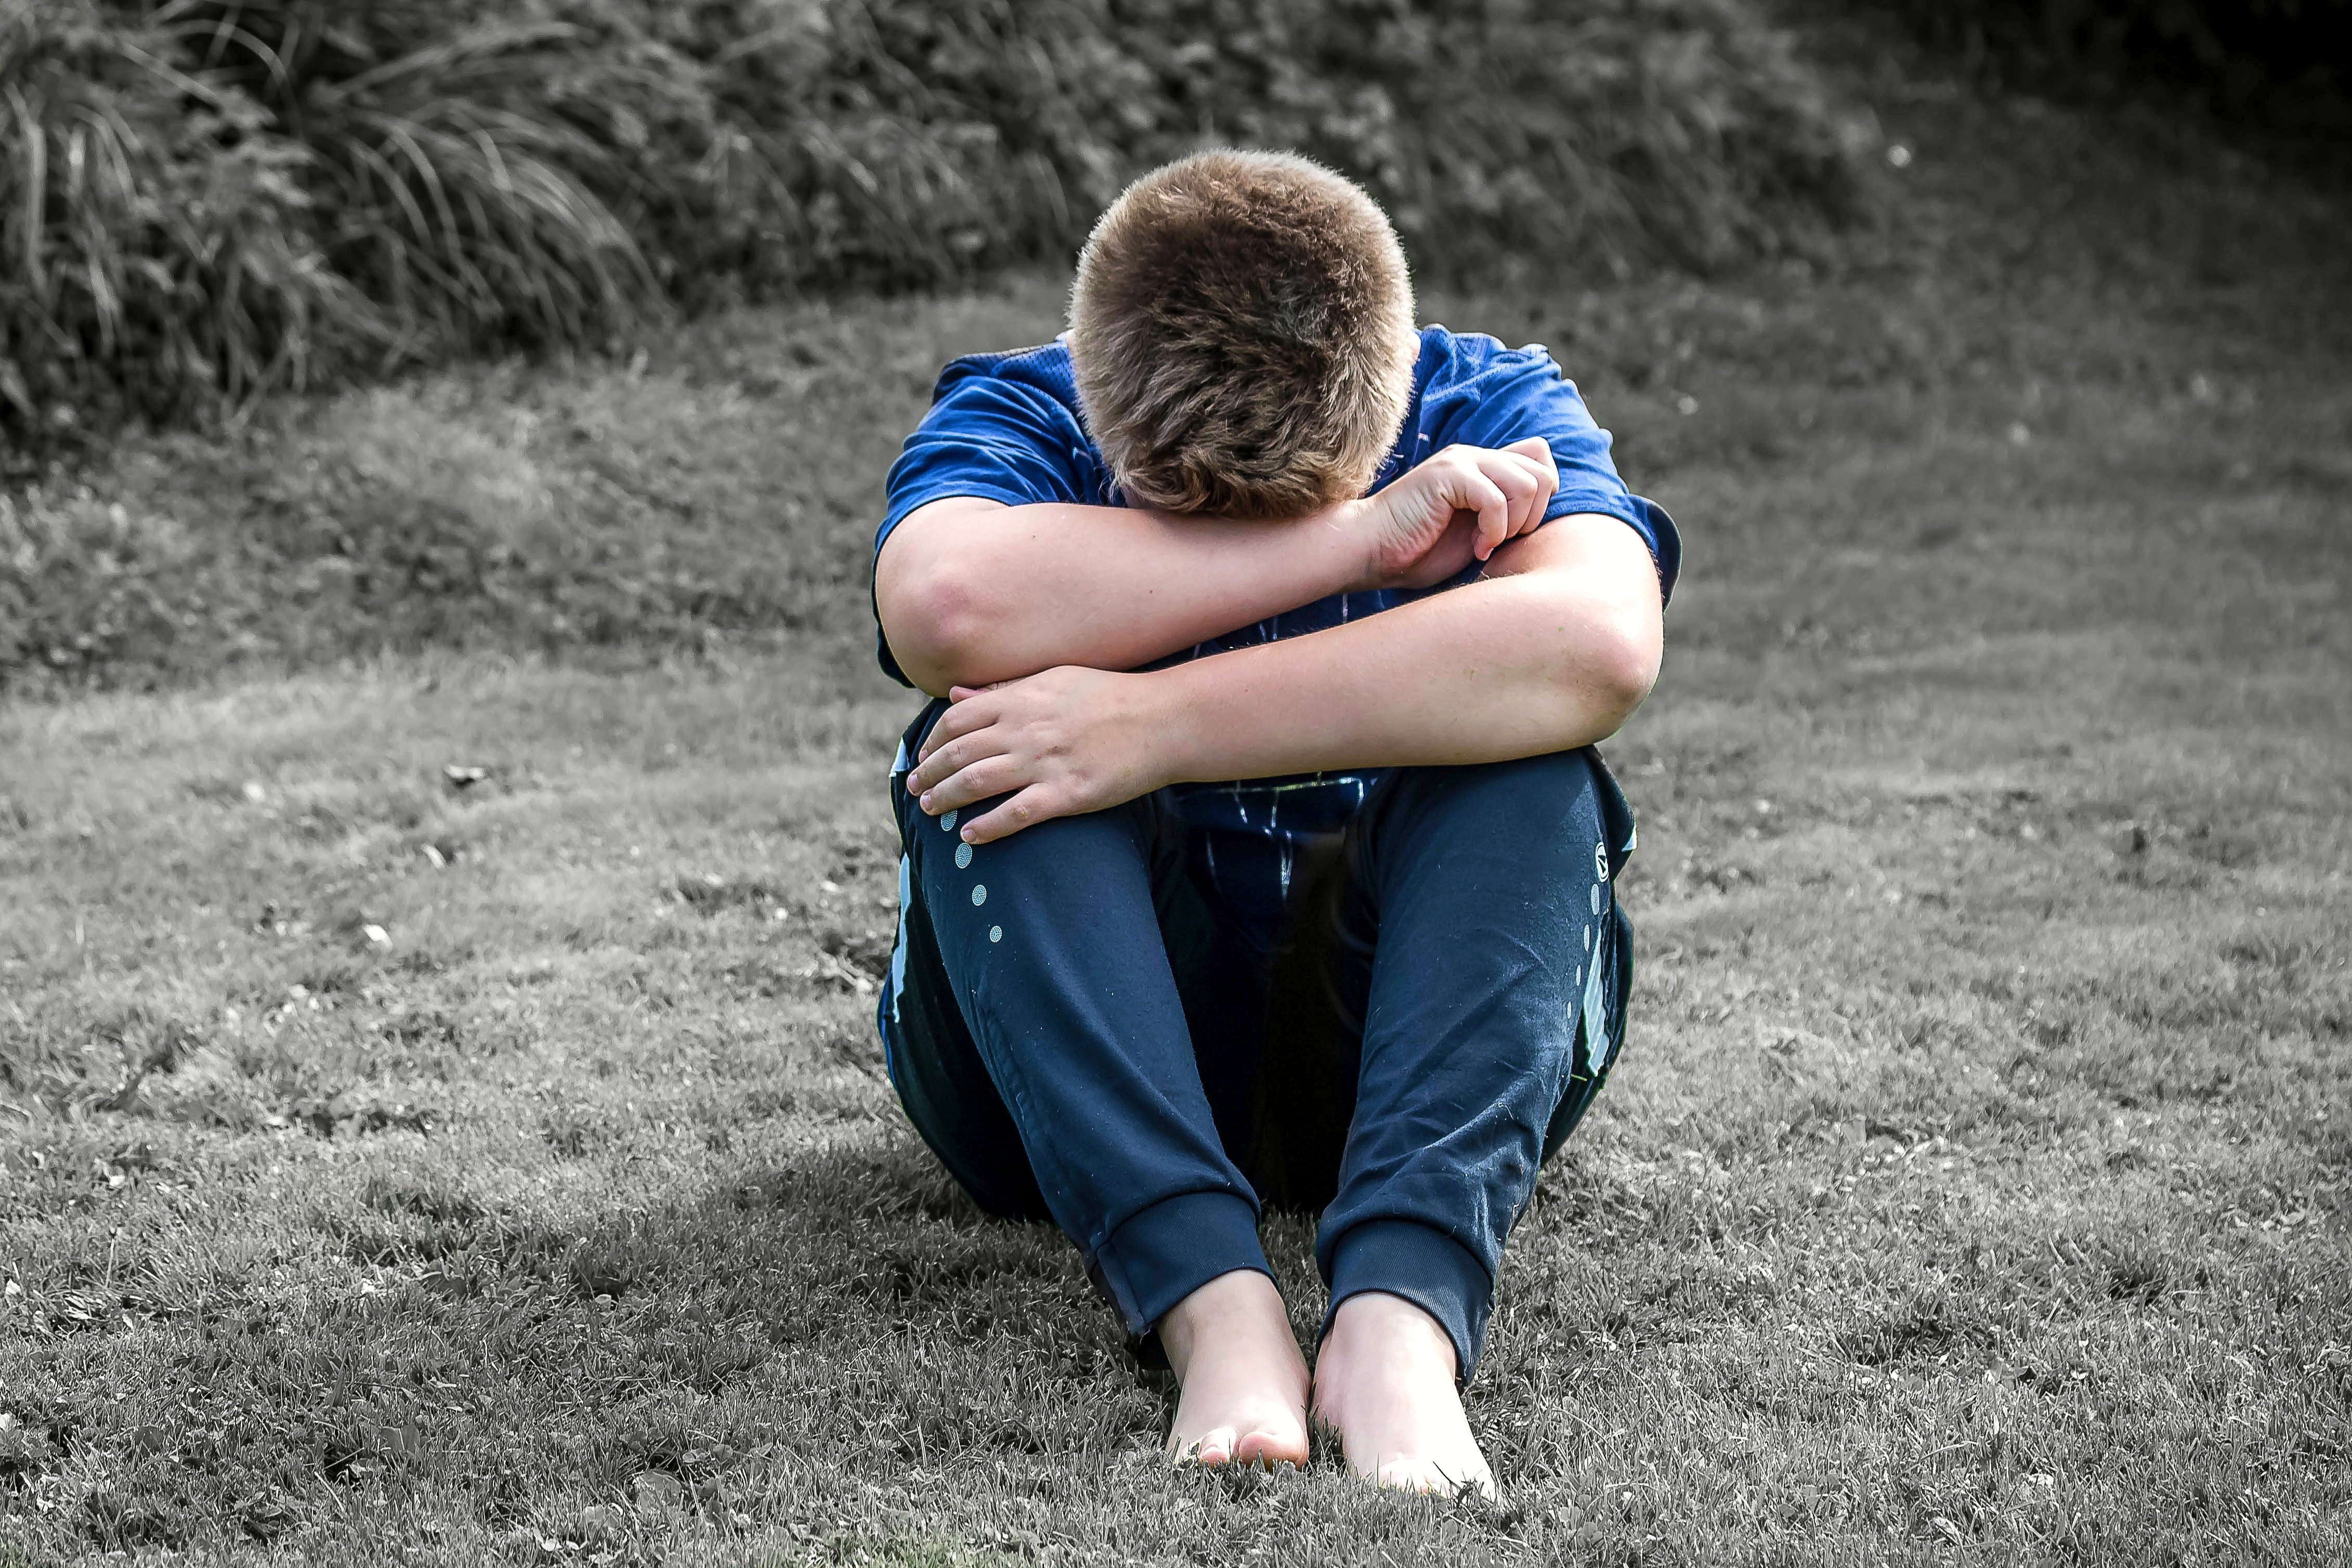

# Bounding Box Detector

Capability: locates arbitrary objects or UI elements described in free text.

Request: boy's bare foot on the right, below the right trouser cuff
[1315,1290,1498,1497]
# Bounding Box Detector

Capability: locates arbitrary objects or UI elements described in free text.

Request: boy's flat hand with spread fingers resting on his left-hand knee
[906,665,1169,844]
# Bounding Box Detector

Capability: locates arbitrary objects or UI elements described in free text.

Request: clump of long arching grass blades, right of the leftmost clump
[155,0,675,357]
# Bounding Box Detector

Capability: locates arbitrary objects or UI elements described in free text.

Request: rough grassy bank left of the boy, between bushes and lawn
[0,284,1002,691]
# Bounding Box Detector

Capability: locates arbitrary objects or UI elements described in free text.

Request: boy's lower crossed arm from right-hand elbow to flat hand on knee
[908,513,1663,844]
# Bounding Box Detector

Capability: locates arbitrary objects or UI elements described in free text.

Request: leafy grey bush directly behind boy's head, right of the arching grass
[647,0,1856,282]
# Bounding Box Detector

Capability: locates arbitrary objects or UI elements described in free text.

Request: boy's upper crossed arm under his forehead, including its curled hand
[875,437,1557,696]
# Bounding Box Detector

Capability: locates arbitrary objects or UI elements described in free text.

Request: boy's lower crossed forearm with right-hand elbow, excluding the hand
[1143,517,1663,780]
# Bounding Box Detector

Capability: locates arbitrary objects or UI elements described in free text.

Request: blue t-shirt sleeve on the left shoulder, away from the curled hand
[875,376,1084,555]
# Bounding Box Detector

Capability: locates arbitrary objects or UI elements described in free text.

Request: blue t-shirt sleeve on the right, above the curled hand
[1430,338,1682,597]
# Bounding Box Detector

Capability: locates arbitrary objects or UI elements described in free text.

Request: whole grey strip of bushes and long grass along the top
[0,0,1858,433]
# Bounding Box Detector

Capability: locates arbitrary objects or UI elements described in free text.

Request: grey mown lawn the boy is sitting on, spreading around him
[0,36,2352,1563]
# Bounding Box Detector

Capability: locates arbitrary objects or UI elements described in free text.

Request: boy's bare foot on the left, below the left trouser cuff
[1159,1270,1308,1469]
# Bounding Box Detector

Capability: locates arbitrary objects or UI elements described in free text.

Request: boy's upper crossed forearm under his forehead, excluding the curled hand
[875,499,1366,696]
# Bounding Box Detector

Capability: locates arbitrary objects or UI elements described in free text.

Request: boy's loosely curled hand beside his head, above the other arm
[1350,435,1559,587]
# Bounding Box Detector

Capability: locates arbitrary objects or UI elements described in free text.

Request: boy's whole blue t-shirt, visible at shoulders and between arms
[875,327,1682,931]
